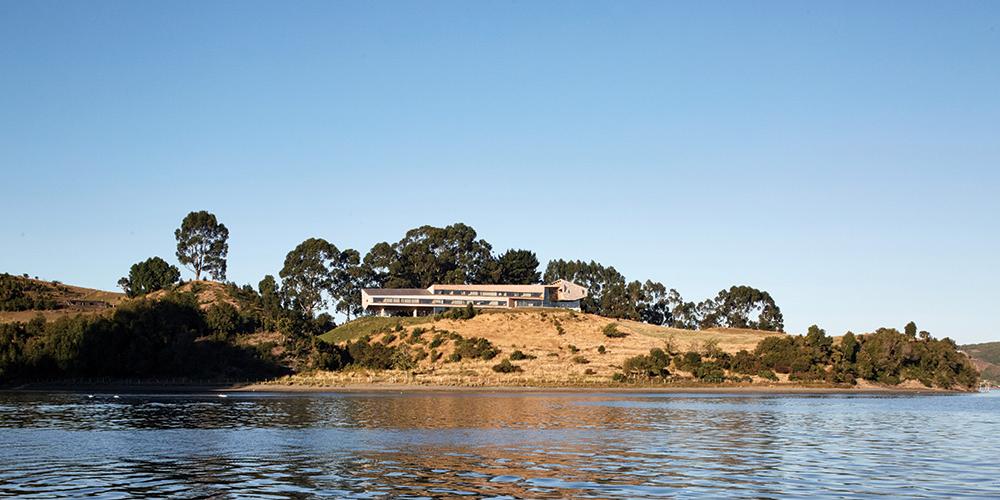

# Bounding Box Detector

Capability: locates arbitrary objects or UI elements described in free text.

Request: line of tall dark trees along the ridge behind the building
[119,211,784,331]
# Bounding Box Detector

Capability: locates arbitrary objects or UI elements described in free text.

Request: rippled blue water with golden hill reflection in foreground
[0,393,1000,498]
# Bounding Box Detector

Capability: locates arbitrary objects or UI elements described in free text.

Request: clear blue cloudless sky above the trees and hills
[0,0,1000,343]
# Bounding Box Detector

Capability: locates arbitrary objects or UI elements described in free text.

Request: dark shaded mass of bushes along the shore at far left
[0,295,281,379]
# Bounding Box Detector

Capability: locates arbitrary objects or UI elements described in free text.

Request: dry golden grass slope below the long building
[310,309,784,385]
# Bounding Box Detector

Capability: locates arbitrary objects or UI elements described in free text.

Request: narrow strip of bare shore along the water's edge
[0,381,971,395]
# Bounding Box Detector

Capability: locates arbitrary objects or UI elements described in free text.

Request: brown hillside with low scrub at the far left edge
[0,274,127,323]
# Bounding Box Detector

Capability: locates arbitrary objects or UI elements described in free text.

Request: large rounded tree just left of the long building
[278,238,360,318]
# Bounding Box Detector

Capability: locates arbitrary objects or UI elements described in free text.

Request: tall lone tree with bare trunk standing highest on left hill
[174,210,229,280]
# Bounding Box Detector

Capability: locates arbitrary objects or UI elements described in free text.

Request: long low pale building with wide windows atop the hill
[361,280,587,316]
